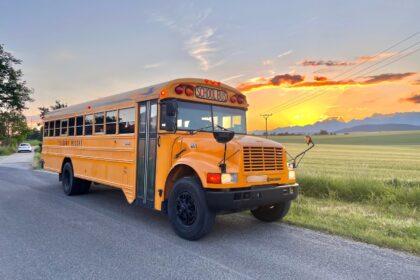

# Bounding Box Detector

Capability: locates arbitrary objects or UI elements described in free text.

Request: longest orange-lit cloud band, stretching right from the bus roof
[236,72,416,92]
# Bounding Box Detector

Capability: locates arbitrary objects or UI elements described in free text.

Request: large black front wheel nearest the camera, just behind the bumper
[168,178,215,240]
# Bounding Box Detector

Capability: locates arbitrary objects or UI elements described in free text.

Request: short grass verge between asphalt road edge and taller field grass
[284,195,420,255]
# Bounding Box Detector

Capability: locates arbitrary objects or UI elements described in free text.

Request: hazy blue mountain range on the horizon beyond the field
[254,112,420,134]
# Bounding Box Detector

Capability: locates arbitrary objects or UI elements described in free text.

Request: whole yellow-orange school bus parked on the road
[42,79,298,240]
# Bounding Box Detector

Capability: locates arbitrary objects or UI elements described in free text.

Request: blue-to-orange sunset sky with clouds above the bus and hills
[0,0,420,131]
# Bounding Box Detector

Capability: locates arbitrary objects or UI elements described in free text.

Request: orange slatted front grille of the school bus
[243,147,283,172]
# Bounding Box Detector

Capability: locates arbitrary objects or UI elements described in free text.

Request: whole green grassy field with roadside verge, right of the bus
[272,131,420,255]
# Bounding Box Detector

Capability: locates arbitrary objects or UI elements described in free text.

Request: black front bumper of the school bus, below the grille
[206,184,299,211]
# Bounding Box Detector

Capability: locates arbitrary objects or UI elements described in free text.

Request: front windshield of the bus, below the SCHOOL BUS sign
[177,101,246,134]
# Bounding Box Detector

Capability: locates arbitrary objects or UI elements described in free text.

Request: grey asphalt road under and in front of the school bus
[0,154,420,279]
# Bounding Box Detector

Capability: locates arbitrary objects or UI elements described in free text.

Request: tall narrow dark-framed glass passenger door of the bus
[137,100,158,208]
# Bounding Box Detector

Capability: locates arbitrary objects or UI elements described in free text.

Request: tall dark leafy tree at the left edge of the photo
[0,44,33,145]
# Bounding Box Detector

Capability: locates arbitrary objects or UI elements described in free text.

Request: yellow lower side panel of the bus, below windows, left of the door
[42,135,136,203]
